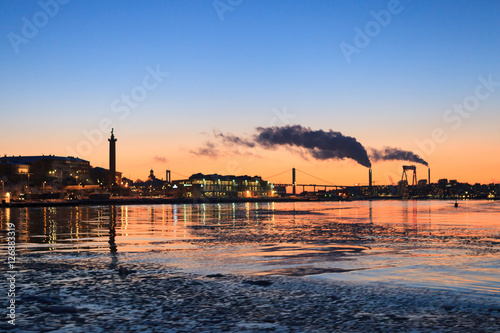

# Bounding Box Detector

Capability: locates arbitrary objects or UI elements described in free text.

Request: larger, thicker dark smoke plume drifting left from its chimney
[254,125,371,168]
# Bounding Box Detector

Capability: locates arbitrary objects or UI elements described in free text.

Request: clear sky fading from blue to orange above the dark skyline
[0,0,500,185]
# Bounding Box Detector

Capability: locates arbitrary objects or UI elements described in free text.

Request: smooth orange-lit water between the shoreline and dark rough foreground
[0,201,500,296]
